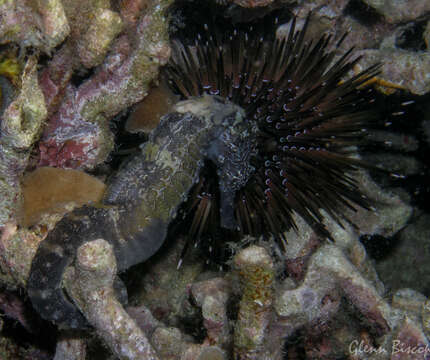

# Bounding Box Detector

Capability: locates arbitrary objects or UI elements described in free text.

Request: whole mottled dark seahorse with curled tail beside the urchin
[27,96,256,328]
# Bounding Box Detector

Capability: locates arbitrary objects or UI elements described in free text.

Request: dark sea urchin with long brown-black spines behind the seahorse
[167,16,378,253]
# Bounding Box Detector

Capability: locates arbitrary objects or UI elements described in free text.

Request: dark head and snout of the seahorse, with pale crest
[176,95,257,230]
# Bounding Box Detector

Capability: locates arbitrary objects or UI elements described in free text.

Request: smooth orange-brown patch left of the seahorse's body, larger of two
[21,167,106,227]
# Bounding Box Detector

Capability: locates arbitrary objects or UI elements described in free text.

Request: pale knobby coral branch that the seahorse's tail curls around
[65,239,159,360]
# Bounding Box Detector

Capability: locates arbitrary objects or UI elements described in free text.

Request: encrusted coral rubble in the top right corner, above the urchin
[288,0,430,95]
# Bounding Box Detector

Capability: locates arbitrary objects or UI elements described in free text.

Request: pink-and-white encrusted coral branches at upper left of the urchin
[39,3,170,168]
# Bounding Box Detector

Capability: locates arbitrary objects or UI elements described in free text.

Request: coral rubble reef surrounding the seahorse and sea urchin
[0,0,430,360]
